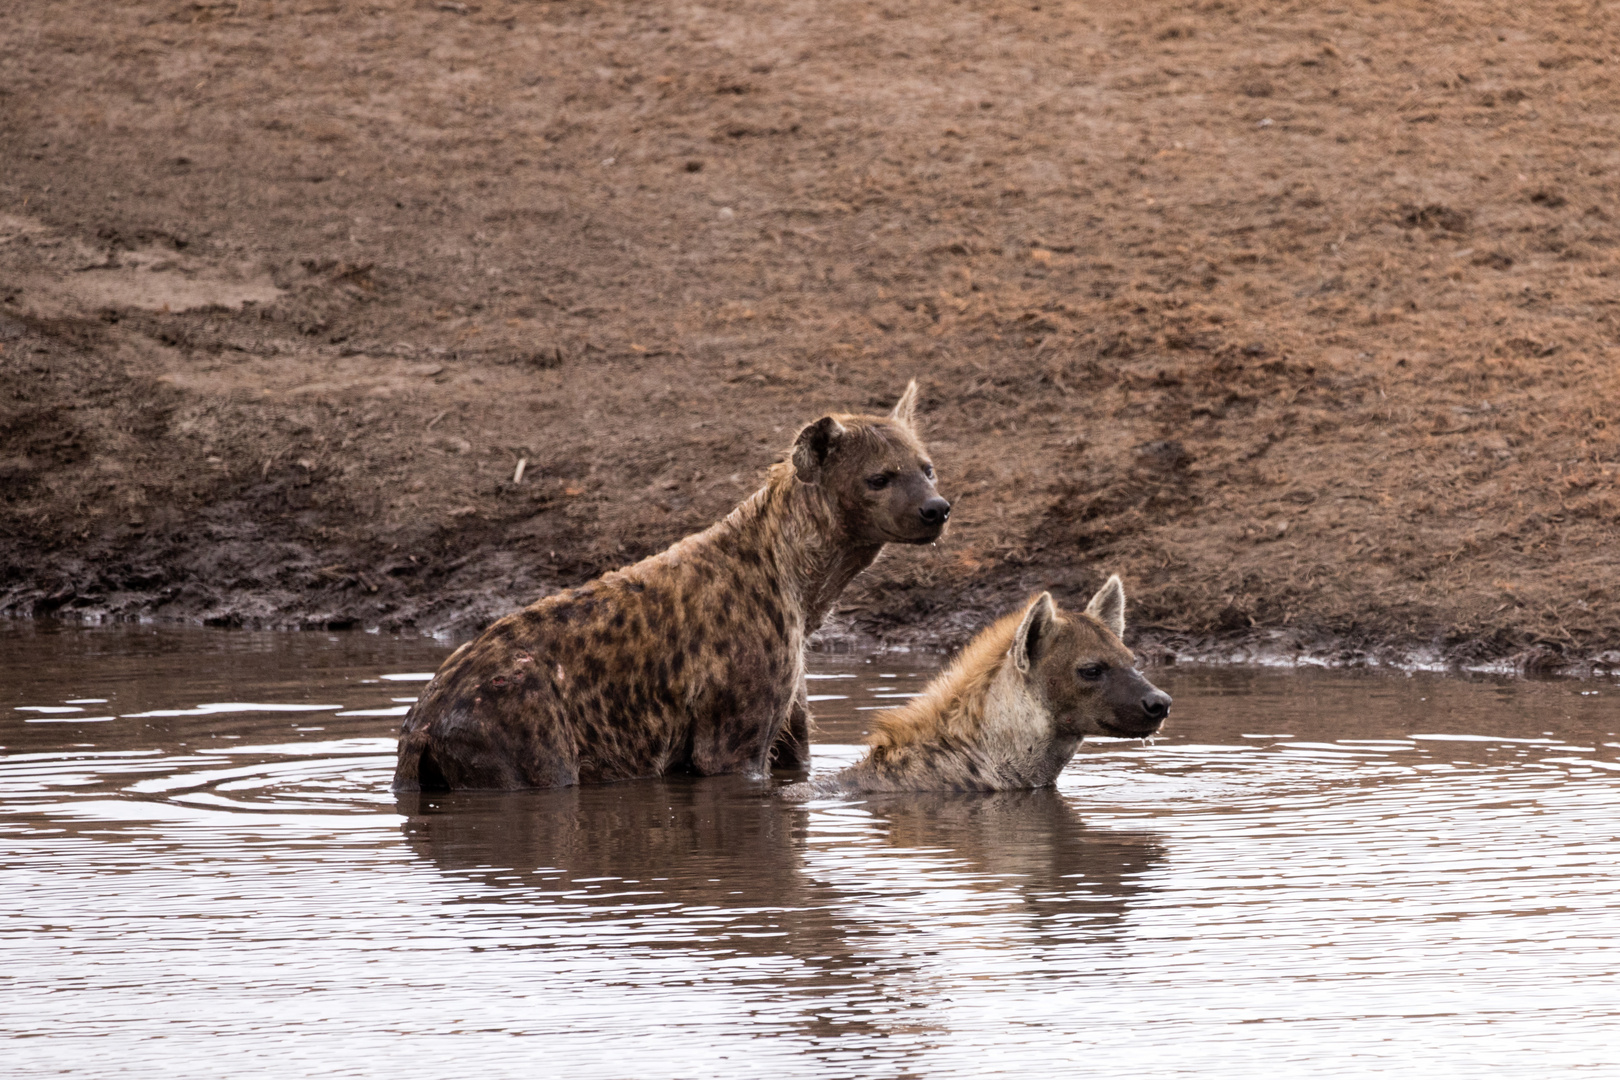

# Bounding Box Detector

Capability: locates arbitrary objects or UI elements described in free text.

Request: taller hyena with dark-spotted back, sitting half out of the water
[394,382,951,790]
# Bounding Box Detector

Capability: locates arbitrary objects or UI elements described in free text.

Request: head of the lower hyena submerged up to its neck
[1013,575,1170,738]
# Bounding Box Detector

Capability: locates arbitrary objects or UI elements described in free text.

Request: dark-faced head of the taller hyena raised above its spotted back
[792,382,951,544]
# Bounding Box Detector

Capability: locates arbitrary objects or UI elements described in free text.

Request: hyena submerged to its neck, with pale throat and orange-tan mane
[782,576,1170,798]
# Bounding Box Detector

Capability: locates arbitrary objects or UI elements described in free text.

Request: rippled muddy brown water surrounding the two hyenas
[0,623,1620,1077]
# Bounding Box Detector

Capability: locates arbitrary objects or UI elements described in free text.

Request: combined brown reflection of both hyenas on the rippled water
[402,779,1162,1065]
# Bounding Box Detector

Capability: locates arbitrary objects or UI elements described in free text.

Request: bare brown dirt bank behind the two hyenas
[0,0,1620,670]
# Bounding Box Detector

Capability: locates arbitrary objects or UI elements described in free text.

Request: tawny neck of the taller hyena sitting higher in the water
[680,463,883,633]
